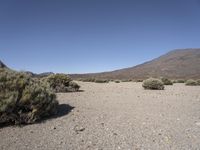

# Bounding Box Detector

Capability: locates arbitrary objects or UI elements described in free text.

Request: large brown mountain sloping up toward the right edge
[70,48,200,79]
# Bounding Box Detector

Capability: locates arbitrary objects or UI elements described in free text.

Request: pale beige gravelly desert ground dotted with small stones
[0,82,200,150]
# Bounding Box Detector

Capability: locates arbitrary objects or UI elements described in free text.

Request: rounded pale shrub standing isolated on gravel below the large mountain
[142,78,164,90]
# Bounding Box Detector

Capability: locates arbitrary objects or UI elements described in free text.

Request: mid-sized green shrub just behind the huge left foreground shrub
[46,74,80,93]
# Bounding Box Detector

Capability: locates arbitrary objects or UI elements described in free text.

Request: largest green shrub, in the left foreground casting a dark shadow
[0,69,58,124]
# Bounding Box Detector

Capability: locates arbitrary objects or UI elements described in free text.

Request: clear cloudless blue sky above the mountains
[0,0,200,73]
